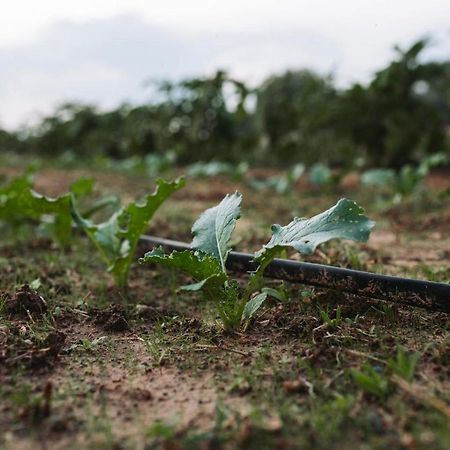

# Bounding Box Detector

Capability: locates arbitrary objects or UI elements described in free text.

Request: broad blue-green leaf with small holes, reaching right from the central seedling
[255,199,375,264]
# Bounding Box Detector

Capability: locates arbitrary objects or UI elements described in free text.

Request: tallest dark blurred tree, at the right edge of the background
[335,40,450,168]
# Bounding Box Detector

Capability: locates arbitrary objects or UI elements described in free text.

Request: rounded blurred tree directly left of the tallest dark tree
[257,70,352,164]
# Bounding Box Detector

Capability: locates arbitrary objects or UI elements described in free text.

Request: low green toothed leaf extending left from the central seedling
[139,247,227,293]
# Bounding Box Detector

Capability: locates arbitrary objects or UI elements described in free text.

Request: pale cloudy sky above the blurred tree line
[0,0,450,129]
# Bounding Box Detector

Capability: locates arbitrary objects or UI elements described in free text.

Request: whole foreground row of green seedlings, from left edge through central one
[0,171,374,330]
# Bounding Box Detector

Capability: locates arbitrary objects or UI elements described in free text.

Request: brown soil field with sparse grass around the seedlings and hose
[0,165,450,450]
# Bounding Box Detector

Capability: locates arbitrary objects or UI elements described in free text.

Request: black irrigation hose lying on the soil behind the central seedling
[140,235,450,313]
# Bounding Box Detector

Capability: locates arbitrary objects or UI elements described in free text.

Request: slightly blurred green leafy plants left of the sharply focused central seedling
[0,171,184,288]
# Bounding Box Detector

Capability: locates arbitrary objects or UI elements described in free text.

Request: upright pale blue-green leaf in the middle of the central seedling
[191,192,242,272]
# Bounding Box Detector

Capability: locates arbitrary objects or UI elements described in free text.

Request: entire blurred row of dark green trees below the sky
[0,39,450,170]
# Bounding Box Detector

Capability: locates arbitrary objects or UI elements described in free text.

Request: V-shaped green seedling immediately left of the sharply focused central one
[72,179,184,287]
